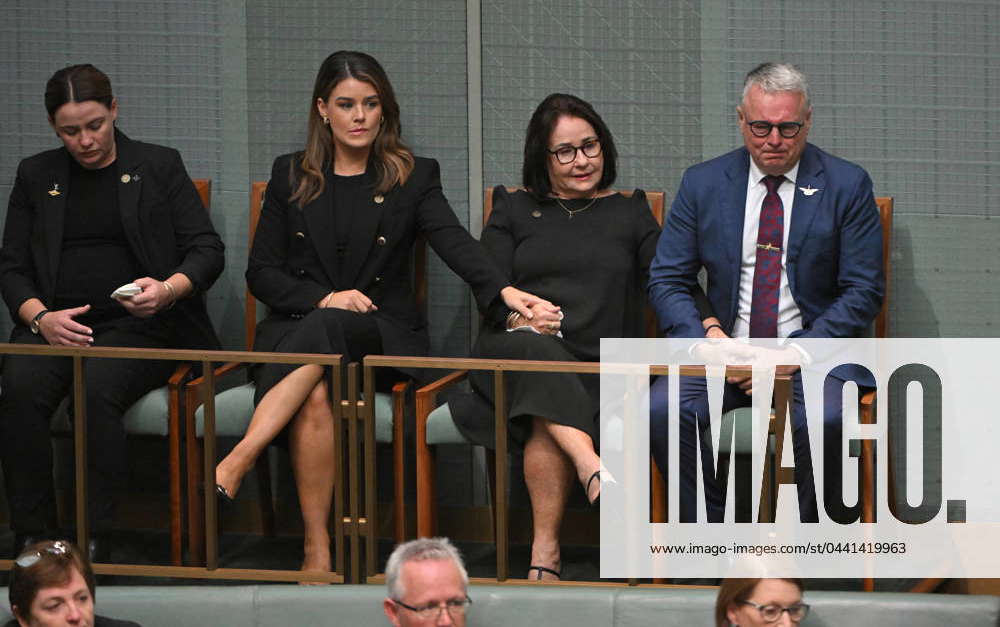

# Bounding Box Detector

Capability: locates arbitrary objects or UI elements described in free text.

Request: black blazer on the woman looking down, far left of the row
[0,130,225,349]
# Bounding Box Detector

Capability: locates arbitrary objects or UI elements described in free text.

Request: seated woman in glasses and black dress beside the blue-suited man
[450,94,716,580]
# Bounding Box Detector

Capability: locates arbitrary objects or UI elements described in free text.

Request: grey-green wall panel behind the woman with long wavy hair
[247,0,469,355]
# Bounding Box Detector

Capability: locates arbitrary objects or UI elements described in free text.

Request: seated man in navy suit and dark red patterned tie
[649,63,885,522]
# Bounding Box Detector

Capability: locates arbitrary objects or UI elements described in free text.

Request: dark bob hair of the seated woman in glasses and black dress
[521,94,618,198]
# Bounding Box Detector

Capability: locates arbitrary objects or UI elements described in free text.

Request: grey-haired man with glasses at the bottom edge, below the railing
[382,538,472,627]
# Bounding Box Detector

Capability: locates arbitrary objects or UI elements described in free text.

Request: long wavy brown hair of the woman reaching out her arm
[289,50,414,207]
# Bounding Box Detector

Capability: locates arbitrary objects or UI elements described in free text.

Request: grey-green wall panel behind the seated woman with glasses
[482,0,702,199]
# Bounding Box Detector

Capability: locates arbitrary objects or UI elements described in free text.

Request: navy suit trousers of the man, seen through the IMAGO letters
[649,373,856,522]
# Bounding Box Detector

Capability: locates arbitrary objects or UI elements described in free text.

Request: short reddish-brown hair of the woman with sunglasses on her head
[7,540,95,619]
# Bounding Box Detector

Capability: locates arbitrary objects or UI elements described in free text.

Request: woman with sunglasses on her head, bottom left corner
[4,540,139,627]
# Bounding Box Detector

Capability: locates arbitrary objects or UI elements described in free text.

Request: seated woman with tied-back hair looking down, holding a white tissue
[0,65,224,561]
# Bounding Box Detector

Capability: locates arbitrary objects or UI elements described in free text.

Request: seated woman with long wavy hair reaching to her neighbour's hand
[215,51,557,570]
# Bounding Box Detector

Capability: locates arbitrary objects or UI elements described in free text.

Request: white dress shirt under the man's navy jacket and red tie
[732,159,802,337]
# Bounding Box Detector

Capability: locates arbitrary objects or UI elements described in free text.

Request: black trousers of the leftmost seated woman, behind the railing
[0,320,175,533]
